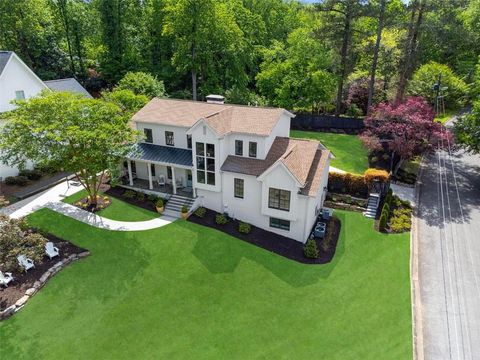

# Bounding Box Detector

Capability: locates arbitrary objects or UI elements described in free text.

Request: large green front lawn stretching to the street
[0,209,412,360]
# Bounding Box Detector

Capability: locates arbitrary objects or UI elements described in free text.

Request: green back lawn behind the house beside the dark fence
[290,130,368,174]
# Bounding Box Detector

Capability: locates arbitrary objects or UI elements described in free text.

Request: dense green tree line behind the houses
[0,0,480,115]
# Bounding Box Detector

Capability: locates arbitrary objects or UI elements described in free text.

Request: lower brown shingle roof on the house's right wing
[221,137,330,196]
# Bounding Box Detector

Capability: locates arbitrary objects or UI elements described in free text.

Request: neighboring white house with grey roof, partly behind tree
[0,51,91,178]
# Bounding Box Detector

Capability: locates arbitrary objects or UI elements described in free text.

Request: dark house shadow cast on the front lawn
[188,216,345,287]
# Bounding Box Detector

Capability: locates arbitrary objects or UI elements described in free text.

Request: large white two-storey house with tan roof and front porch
[125,98,331,242]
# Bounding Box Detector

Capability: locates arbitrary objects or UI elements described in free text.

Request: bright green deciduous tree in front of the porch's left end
[0,92,135,206]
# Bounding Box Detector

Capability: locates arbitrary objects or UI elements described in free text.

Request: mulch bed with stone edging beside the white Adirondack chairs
[0,234,87,310]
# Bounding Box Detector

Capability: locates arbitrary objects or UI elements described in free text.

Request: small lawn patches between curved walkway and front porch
[63,190,159,221]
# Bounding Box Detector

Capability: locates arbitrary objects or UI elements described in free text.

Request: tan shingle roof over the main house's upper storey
[133,98,285,136]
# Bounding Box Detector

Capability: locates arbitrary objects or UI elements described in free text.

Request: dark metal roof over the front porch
[127,143,193,166]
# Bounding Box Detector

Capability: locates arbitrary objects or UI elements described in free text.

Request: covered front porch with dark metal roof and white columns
[123,143,196,197]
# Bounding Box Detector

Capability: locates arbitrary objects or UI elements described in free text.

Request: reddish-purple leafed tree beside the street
[361,97,452,174]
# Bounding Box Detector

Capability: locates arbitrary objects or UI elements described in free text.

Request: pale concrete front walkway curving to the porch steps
[0,181,177,231]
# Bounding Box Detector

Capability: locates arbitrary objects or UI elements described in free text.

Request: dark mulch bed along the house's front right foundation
[188,209,340,264]
